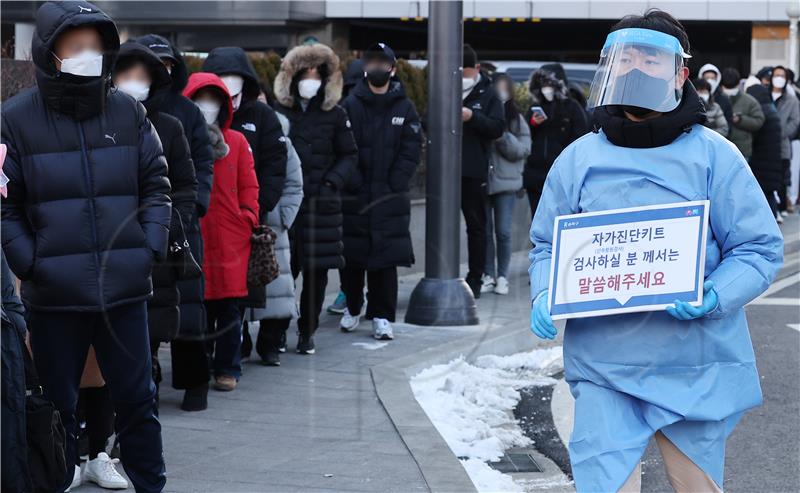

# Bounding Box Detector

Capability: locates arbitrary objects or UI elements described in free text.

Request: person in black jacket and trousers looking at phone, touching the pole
[461,45,506,298]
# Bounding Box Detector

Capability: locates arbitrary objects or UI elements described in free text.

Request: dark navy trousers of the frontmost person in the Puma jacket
[29,302,166,493]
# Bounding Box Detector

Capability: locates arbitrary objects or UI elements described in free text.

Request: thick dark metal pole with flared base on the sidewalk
[405,1,478,325]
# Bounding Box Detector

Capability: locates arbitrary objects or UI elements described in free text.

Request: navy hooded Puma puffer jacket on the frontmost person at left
[2,2,171,312]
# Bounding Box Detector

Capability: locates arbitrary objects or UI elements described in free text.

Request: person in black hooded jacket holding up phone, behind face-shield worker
[522,69,589,215]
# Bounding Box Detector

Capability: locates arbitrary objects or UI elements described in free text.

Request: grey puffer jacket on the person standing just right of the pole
[487,115,531,195]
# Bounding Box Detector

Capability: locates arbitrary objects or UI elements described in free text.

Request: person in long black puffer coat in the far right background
[747,84,783,215]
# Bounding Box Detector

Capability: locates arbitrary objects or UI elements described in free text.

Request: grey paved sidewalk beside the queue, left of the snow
[77,252,544,492]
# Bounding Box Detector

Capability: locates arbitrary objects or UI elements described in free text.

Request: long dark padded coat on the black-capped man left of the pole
[342,78,422,270]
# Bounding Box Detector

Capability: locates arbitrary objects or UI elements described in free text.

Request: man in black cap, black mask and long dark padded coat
[341,43,422,339]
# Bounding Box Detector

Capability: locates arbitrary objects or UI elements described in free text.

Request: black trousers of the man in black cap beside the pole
[341,267,397,322]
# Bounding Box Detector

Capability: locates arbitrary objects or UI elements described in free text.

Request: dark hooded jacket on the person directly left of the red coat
[136,34,214,217]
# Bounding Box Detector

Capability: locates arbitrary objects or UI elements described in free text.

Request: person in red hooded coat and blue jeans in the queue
[183,72,258,391]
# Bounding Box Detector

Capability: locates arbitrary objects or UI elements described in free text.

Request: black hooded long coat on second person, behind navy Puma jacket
[114,41,197,341]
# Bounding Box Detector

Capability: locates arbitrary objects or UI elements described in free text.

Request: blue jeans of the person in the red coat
[205,298,242,380]
